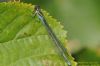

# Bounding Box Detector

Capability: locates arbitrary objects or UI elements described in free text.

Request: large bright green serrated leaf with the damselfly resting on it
[0,2,76,66]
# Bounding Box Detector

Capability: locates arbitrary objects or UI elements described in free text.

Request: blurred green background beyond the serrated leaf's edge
[0,0,100,64]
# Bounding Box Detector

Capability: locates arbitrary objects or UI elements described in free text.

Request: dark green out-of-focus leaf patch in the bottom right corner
[74,48,100,66]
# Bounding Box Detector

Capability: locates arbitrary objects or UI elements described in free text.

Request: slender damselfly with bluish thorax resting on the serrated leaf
[34,5,72,66]
